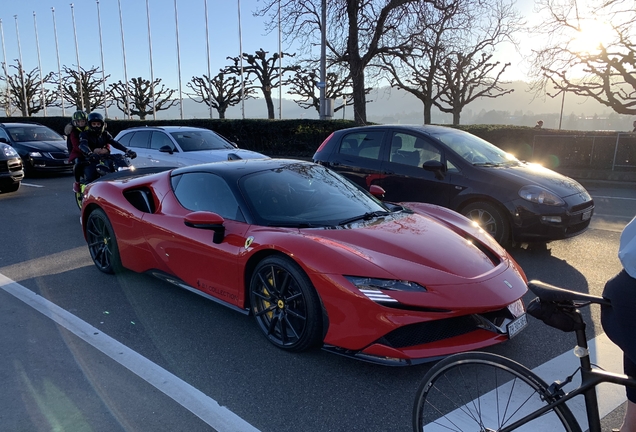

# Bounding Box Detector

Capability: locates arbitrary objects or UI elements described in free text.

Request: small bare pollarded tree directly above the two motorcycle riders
[53,65,110,112]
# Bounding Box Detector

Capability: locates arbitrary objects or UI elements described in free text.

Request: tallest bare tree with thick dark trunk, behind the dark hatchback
[256,0,447,124]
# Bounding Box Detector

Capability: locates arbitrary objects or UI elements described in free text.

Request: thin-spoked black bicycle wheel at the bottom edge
[413,352,581,432]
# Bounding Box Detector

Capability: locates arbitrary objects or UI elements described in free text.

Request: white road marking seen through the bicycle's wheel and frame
[424,334,627,431]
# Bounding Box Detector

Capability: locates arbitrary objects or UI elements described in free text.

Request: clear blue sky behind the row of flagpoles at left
[0,0,288,91]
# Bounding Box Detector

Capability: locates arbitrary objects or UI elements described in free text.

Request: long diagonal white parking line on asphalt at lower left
[0,274,258,432]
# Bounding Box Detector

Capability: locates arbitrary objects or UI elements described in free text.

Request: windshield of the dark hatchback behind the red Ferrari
[431,130,519,165]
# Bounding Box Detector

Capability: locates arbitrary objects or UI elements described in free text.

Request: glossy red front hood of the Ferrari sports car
[305,214,507,283]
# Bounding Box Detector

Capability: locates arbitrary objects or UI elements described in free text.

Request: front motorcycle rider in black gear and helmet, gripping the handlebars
[79,112,137,183]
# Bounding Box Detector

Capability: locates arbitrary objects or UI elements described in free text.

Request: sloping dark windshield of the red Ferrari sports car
[239,164,388,227]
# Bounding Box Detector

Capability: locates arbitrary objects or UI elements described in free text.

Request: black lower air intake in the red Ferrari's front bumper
[378,315,478,348]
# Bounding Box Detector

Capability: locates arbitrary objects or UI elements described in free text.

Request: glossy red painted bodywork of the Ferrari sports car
[82,165,527,361]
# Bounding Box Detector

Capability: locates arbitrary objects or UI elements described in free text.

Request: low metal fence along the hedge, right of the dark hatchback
[531,133,636,171]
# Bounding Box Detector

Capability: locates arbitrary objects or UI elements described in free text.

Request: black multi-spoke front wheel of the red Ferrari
[250,256,322,351]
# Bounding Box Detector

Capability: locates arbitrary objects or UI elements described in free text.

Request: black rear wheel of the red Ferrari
[86,209,124,273]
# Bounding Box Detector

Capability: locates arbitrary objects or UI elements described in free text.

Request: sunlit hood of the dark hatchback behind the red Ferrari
[483,162,587,197]
